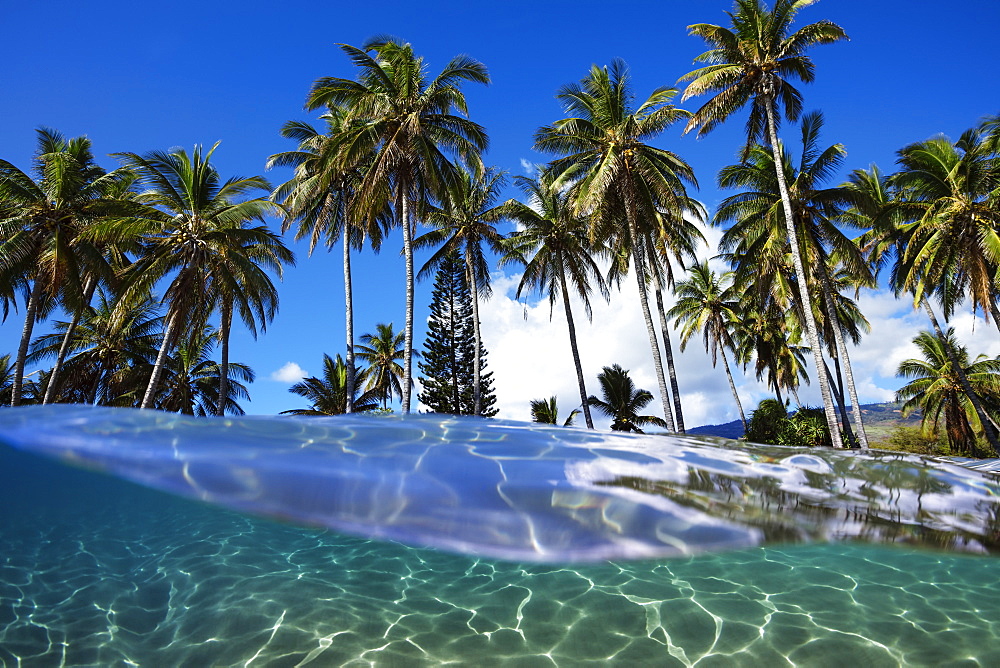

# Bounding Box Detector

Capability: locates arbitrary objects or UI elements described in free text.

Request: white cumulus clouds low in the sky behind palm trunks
[480,262,1000,428]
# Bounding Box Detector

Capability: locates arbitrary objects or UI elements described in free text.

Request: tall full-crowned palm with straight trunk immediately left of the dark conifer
[306,37,489,414]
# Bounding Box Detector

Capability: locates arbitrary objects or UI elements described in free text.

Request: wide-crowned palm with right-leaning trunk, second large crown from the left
[108,142,280,408]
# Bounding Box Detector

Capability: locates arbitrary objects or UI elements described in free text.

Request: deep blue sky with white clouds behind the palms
[0,0,1000,426]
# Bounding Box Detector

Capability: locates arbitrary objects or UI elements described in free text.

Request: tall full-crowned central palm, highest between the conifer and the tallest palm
[535,60,697,428]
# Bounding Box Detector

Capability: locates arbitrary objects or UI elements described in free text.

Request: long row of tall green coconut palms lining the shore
[0,0,1000,451]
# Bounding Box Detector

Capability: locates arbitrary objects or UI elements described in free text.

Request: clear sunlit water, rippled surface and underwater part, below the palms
[0,407,1000,666]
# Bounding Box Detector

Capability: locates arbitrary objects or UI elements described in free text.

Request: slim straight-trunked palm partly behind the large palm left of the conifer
[267,106,391,413]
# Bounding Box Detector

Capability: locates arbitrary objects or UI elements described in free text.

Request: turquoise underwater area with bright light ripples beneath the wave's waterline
[0,408,1000,666]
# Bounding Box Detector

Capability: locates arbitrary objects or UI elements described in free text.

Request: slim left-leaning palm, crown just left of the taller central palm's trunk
[501,168,608,429]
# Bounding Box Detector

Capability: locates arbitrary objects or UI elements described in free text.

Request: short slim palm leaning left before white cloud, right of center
[667,262,747,431]
